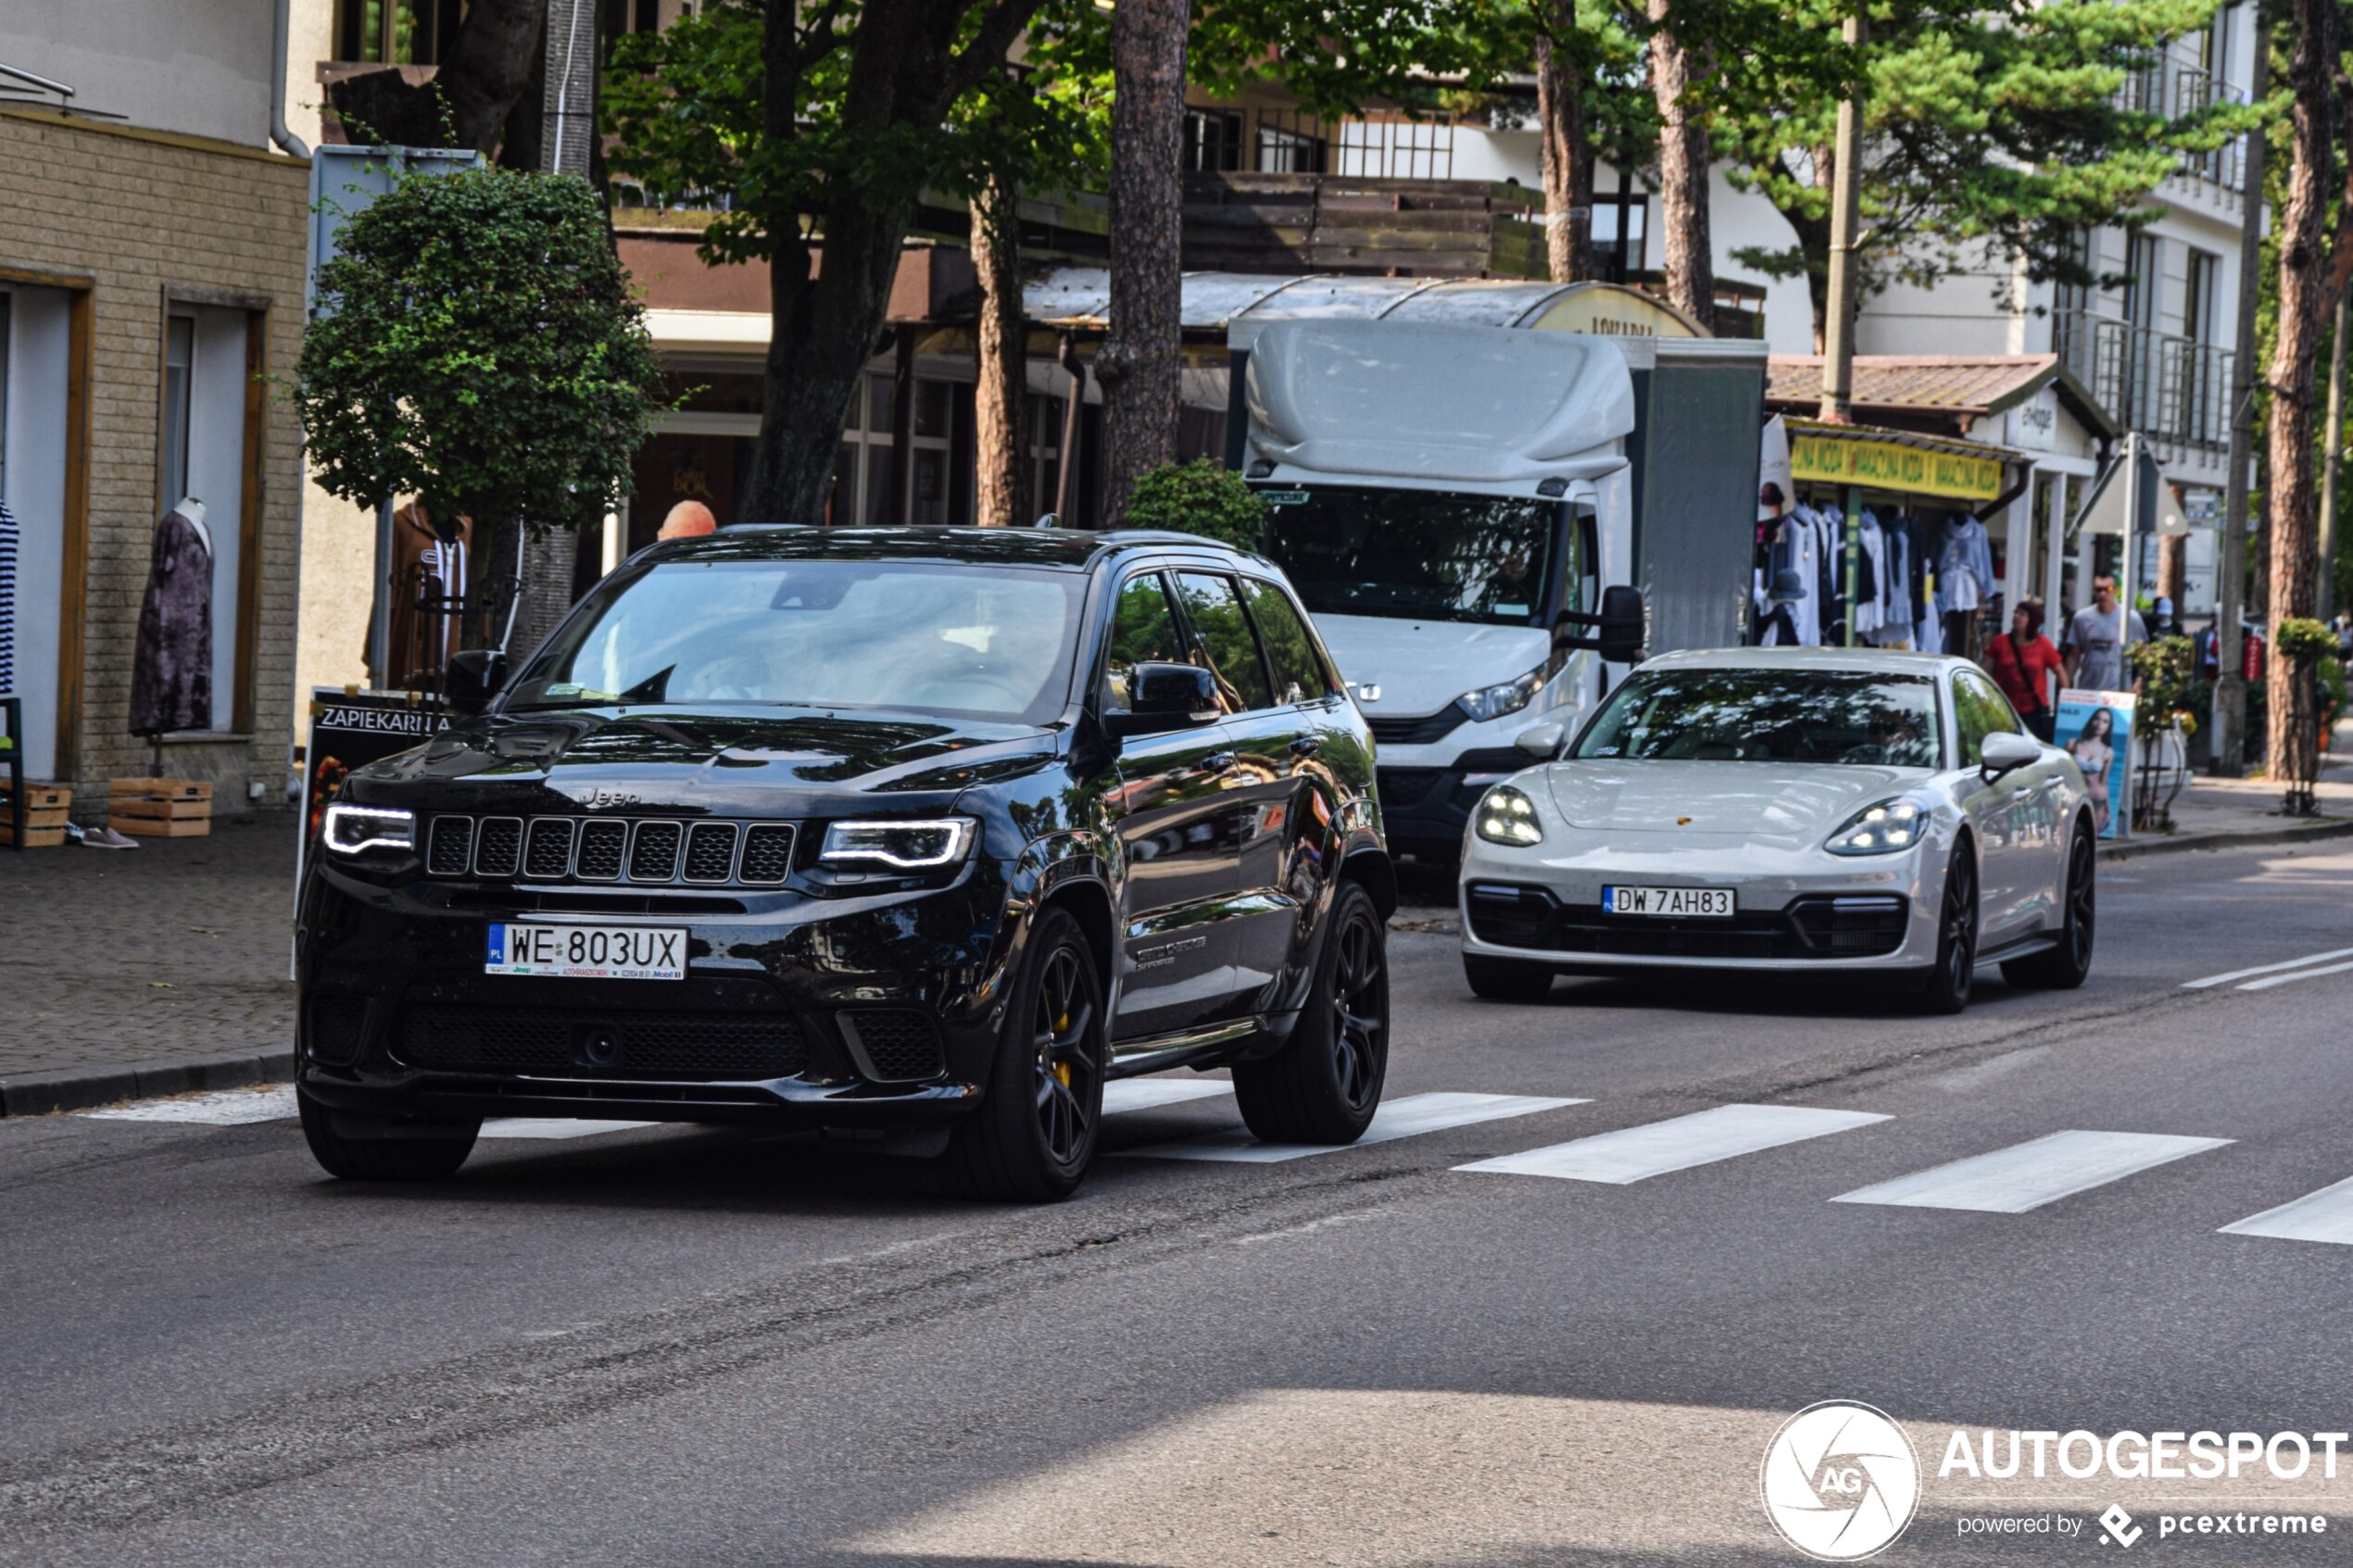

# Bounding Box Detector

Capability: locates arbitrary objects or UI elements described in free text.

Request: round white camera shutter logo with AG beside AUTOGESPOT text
[1762,1399,1920,1563]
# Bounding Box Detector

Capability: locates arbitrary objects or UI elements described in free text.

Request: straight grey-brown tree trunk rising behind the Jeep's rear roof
[1094,0,1189,527]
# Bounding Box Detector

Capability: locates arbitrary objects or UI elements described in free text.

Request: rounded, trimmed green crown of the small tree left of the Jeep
[295,169,659,532]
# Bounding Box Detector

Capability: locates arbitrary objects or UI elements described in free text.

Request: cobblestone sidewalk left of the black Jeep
[0,813,295,1077]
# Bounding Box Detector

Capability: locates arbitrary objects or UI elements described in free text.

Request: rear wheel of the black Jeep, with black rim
[1233,882,1389,1145]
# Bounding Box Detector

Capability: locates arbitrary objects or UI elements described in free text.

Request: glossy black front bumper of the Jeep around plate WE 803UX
[296,863,1019,1126]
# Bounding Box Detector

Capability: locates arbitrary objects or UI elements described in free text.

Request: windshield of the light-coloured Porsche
[1572,668,1944,769]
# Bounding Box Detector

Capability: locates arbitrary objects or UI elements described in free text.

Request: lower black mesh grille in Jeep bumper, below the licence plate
[397,1004,810,1082]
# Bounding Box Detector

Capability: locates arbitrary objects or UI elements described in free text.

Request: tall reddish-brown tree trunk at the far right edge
[2263,0,2341,811]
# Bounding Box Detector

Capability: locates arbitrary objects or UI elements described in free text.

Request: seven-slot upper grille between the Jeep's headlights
[426,816,796,886]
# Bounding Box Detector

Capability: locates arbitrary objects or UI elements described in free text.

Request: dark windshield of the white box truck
[1259,486,1565,625]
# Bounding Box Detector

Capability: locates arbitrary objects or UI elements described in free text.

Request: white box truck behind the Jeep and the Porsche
[1238,320,1765,858]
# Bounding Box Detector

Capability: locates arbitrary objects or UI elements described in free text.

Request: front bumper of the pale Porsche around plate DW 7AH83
[1456,834,1942,973]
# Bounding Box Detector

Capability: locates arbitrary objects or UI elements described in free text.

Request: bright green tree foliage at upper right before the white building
[1720,0,2263,315]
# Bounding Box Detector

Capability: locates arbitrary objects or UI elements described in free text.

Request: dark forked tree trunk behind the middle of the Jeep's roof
[741,0,1044,521]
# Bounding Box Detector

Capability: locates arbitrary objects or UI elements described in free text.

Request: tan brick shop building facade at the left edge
[0,0,308,816]
